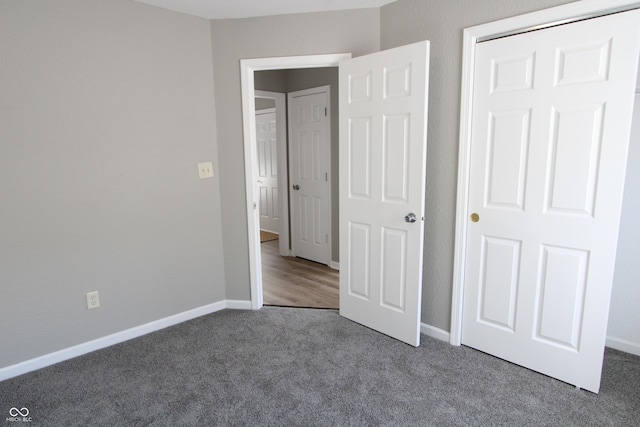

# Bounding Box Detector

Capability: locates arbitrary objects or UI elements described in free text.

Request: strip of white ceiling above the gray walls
[134,0,396,19]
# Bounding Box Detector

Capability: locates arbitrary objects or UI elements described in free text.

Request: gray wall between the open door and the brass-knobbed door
[380,0,570,331]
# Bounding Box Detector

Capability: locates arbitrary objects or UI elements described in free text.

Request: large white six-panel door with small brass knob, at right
[462,11,640,392]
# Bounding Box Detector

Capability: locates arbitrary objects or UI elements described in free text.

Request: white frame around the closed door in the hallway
[287,85,335,266]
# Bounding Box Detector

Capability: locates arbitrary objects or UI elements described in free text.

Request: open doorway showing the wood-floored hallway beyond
[254,82,339,309]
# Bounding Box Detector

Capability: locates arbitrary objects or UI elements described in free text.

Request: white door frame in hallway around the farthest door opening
[254,90,290,256]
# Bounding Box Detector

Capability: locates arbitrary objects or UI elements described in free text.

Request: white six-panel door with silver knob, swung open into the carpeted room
[339,41,429,346]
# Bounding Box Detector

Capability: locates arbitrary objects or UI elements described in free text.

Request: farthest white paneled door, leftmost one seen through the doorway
[256,108,280,234]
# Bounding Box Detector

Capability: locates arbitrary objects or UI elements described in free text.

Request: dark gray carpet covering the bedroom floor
[0,307,640,426]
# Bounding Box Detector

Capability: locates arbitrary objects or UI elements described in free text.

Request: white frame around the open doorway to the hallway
[240,53,351,310]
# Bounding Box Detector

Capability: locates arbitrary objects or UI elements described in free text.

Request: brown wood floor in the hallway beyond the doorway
[261,240,340,309]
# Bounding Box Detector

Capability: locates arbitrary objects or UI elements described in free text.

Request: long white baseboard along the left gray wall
[0,300,251,381]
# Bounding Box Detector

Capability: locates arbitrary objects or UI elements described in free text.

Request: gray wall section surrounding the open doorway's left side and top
[211,8,380,300]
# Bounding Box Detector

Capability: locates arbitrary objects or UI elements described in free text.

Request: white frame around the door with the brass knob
[450,0,640,345]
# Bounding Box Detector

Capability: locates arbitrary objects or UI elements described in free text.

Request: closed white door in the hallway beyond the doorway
[288,86,331,265]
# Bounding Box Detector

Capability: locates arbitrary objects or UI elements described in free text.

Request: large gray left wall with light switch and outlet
[0,0,225,368]
